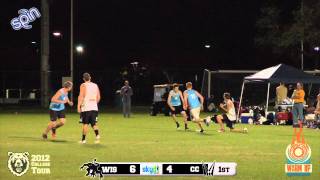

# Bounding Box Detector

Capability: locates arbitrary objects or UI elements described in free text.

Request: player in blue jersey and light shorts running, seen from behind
[183,82,209,133]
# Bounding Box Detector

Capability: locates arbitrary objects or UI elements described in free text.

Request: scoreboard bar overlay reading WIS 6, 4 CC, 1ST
[79,161,237,176]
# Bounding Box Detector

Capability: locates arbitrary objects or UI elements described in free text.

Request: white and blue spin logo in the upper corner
[10,7,41,30]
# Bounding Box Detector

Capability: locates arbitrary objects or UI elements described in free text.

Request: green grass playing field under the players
[0,108,320,180]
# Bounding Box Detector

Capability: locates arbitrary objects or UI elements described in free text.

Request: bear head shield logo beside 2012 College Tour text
[8,152,29,176]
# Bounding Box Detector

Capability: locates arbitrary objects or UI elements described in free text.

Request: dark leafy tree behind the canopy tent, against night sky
[255,0,320,68]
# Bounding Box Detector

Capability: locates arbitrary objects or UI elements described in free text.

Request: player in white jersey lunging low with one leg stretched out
[216,92,248,133]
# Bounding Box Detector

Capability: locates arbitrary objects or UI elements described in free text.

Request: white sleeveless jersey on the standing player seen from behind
[81,82,99,112]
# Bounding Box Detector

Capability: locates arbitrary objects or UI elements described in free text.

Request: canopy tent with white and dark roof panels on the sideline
[238,64,320,117]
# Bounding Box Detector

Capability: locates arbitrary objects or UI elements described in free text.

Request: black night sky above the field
[0,0,312,103]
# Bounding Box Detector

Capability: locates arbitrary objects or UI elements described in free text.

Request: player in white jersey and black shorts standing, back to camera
[77,73,101,144]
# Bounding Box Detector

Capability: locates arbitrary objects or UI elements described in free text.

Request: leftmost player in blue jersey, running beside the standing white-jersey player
[42,81,73,139]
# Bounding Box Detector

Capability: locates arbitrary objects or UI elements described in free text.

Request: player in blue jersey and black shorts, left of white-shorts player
[167,83,189,130]
